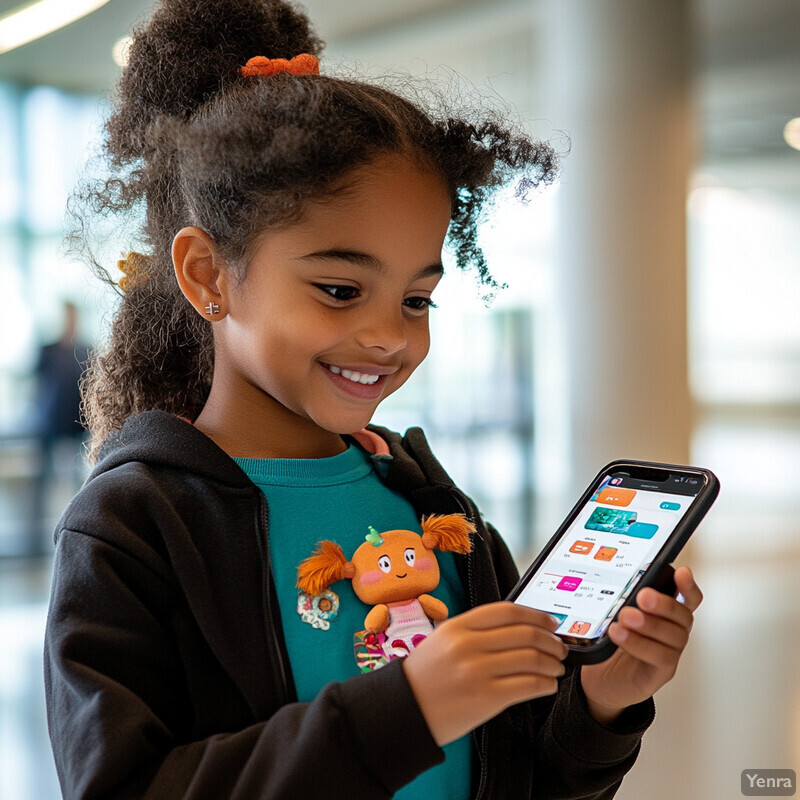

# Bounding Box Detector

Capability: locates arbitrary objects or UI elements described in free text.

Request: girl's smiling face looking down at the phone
[212,155,451,454]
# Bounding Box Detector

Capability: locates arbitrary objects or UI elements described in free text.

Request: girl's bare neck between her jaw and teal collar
[194,380,347,458]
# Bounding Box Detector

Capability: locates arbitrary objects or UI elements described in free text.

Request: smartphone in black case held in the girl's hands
[508,461,719,664]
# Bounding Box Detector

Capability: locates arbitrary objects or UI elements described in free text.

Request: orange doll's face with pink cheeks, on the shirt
[351,531,439,606]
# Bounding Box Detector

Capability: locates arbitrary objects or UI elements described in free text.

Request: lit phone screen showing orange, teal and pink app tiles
[515,472,705,640]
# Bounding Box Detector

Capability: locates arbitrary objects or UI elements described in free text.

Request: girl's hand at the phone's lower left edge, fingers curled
[403,602,567,747]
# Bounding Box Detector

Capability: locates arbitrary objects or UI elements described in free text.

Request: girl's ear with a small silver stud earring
[172,226,228,322]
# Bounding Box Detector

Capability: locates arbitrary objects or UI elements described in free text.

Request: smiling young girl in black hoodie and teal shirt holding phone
[45,0,701,800]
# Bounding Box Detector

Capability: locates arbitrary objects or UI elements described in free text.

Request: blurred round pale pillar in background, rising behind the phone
[539,0,693,491]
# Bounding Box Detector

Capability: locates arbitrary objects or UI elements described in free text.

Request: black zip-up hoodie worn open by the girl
[45,411,654,800]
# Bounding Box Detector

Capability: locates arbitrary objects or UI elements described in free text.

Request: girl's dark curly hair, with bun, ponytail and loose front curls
[78,0,557,457]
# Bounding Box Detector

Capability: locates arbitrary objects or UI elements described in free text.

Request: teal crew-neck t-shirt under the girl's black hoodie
[235,445,472,800]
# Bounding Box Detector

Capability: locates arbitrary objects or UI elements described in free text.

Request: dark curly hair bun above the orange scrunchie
[108,0,324,162]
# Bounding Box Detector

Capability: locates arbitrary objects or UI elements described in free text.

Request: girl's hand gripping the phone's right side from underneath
[581,567,703,723]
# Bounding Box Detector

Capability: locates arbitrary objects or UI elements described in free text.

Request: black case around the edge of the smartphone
[507,459,719,664]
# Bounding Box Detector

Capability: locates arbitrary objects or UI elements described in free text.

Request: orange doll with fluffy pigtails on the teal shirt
[297,514,475,672]
